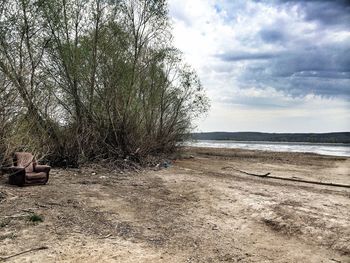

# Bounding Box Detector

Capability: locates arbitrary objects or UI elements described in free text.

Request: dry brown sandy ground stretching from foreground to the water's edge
[0,148,350,263]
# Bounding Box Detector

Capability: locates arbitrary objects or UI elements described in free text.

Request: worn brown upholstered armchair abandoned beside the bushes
[1,152,51,186]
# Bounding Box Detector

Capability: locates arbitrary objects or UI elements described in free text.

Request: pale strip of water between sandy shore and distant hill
[185,140,350,157]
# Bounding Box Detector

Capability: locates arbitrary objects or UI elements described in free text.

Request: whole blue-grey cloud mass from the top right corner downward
[213,0,350,98]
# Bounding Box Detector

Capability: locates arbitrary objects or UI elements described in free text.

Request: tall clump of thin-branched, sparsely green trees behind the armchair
[0,0,209,165]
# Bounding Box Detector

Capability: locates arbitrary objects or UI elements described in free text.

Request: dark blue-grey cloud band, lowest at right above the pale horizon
[230,44,350,98]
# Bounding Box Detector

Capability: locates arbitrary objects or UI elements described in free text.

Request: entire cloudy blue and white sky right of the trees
[169,0,350,132]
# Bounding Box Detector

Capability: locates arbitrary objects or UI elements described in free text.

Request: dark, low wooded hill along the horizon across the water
[191,132,350,143]
